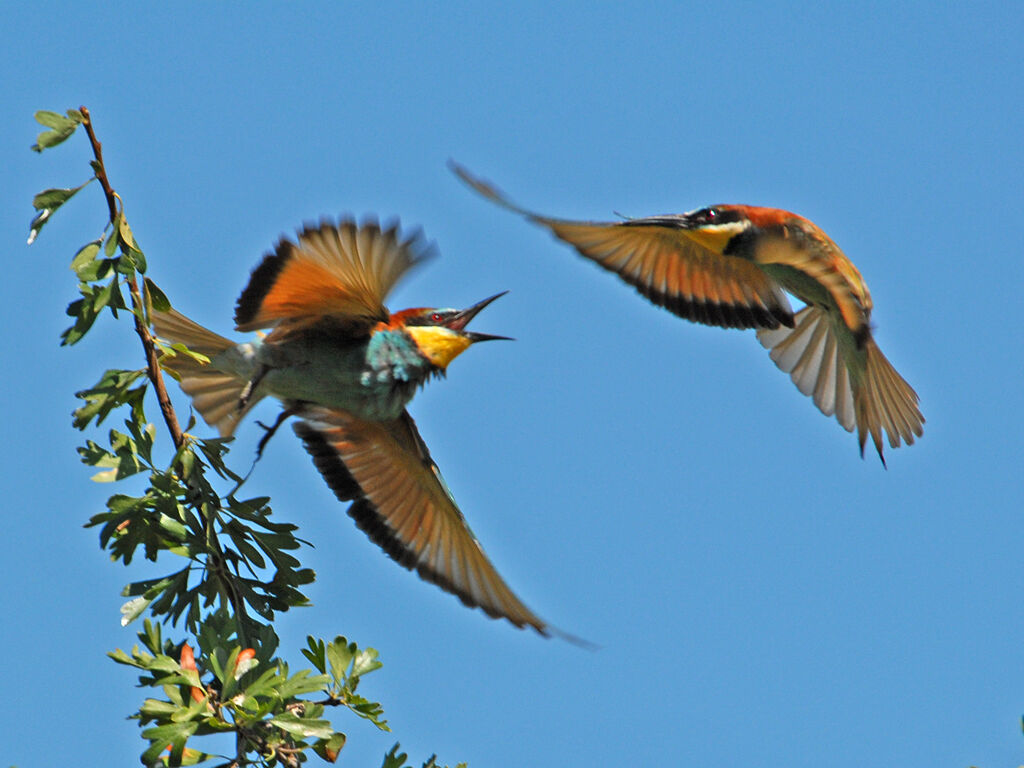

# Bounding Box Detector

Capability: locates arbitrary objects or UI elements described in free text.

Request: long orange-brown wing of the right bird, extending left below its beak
[450,163,793,328]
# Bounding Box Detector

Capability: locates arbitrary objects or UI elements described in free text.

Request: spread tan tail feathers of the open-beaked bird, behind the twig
[153,309,261,437]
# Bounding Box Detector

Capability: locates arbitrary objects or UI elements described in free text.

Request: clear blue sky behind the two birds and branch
[0,2,1024,768]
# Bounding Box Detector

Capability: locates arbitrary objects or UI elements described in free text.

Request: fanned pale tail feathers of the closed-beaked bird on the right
[758,306,925,464]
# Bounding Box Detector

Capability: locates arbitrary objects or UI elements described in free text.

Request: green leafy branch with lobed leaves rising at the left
[29,106,464,768]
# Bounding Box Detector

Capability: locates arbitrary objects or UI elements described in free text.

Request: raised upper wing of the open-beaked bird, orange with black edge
[234,219,433,336]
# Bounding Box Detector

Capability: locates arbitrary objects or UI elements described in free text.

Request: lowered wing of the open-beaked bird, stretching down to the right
[294,407,549,636]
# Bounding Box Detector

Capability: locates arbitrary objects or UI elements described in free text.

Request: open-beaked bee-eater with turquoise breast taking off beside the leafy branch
[153,220,549,635]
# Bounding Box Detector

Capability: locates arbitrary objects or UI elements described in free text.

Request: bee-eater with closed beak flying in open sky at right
[451,163,925,465]
